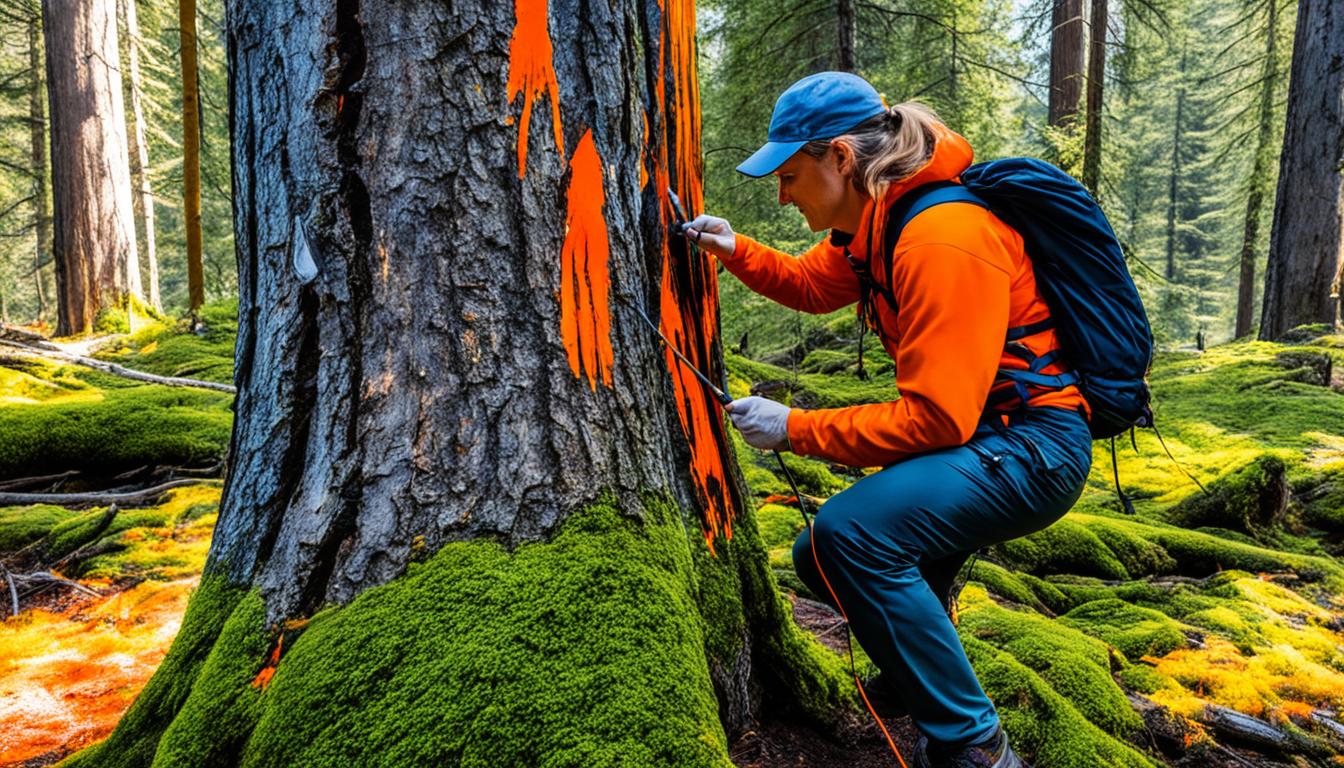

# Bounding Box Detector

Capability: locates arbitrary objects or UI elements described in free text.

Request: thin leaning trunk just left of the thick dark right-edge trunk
[1234,0,1279,339]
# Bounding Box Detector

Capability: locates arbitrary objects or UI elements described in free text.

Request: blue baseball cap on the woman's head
[738,73,887,176]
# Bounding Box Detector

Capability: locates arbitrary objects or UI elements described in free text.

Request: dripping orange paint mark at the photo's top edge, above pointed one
[505,0,564,179]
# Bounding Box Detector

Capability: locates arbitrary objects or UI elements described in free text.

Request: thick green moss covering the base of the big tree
[63,496,849,768]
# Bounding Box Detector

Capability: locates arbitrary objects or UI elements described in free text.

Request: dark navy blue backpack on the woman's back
[851,157,1153,438]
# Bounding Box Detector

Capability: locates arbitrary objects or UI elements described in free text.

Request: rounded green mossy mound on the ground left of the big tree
[0,362,233,477]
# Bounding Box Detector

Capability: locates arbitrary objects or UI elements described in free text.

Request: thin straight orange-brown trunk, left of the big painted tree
[177,0,206,321]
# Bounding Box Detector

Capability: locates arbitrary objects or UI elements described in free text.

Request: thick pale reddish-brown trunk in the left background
[42,0,136,334]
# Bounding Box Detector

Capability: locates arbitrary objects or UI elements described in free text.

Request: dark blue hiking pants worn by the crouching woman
[793,408,1091,745]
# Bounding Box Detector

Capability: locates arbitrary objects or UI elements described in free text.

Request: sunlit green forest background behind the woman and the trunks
[0,0,1296,351]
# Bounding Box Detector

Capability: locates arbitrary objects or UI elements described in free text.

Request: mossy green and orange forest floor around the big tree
[0,304,1344,768]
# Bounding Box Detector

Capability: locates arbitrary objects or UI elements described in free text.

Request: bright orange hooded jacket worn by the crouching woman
[723,129,1086,467]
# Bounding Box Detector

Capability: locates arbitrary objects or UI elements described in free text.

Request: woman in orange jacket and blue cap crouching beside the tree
[684,73,1091,768]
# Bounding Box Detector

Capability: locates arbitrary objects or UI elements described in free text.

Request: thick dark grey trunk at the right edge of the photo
[1259,0,1344,340]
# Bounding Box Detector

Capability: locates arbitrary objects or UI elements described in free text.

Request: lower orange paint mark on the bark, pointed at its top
[560,130,613,390]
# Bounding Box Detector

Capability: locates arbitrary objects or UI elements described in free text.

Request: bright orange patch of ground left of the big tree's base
[0,578,199,765]
